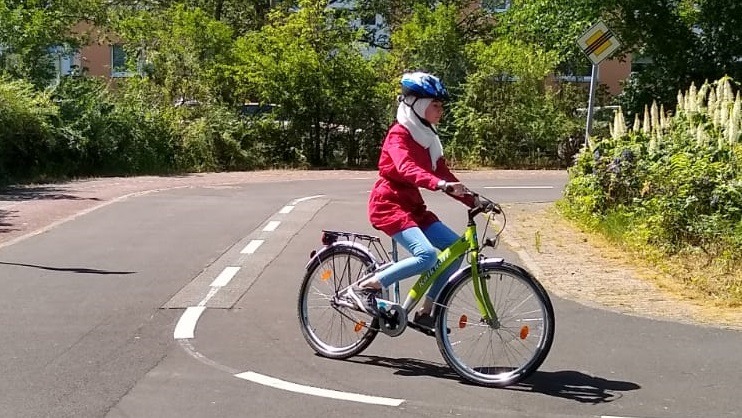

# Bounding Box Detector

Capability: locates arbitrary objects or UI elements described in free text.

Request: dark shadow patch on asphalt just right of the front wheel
[505,370,641,404]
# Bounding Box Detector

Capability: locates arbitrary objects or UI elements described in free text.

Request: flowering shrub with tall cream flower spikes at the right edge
[561,79,742,300]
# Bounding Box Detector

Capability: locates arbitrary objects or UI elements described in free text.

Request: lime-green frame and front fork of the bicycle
[391,212,497,320]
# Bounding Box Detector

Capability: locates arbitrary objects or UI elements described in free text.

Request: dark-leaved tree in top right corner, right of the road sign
[615,0,742,112]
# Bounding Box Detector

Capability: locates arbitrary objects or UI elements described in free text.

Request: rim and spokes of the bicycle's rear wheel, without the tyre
[302,250,372,354]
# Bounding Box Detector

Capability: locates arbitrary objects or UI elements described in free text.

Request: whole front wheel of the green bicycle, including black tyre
[436,262,554,387]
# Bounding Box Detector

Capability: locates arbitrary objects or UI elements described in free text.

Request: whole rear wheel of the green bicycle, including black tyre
[298,245,378,359]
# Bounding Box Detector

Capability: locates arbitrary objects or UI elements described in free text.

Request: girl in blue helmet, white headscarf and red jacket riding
[346,72,475,329]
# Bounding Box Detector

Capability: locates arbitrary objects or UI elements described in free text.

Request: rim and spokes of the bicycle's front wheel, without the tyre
[440,271,551,384]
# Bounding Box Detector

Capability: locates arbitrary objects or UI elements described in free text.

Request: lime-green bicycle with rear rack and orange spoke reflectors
[298,194,554,387]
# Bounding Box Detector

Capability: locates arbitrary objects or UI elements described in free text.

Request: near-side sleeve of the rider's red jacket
[385,131,442,190]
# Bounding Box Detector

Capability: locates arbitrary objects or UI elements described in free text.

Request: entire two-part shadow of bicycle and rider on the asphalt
[345,355,641,404]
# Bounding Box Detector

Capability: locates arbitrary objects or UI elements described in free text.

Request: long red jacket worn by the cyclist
[368,124,474,236]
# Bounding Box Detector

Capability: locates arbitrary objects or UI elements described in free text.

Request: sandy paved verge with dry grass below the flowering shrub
[503,203,742,329]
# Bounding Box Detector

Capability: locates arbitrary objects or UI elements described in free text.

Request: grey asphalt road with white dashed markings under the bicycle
[0,175,742,418]
